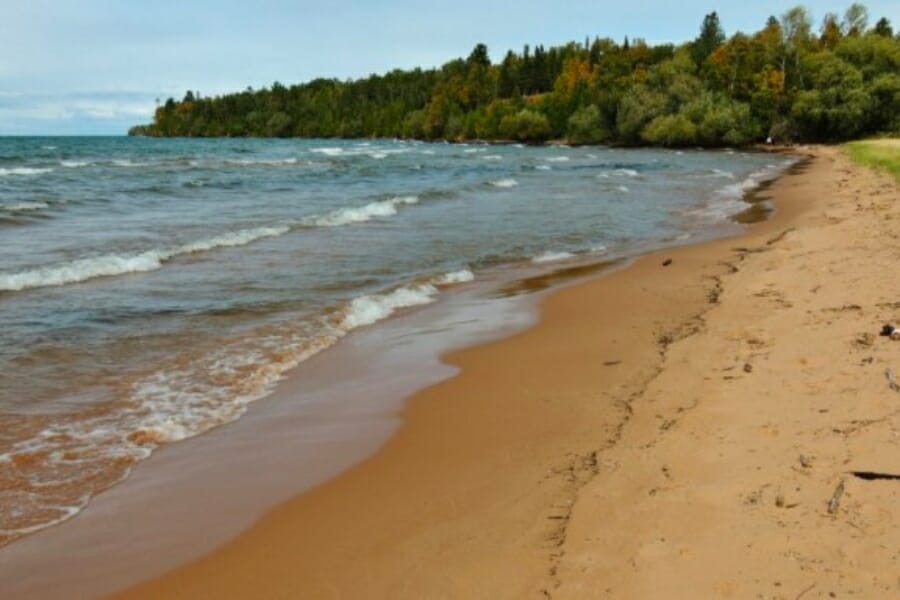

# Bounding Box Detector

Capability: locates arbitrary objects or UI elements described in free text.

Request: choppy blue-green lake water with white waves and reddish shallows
[0,138,787,544]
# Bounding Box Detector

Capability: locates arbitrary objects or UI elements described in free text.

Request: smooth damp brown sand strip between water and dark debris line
[110,148,891,598]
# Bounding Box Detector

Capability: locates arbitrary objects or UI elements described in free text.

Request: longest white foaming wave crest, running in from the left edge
[0,226,290,292]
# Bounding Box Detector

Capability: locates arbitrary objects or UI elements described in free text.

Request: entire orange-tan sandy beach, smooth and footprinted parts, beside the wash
[121,147,900,599]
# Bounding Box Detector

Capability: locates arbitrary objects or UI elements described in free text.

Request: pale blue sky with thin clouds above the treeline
[0,0,900,135]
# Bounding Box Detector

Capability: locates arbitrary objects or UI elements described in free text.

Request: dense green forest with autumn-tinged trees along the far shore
[129,4,900,147]
